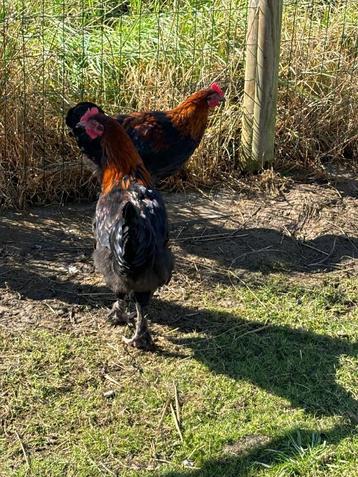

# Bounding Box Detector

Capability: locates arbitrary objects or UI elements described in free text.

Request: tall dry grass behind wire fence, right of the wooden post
[277,2,358,174]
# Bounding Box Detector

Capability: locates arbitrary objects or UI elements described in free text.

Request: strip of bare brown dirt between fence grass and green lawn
[0,180,358,330]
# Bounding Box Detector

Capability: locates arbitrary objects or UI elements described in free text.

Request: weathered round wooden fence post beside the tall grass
[241,0,283,171]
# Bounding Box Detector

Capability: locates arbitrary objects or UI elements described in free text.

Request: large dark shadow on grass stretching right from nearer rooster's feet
[151,301,358,422]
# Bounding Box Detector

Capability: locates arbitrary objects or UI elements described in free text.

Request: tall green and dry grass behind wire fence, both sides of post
[0,0,358,207]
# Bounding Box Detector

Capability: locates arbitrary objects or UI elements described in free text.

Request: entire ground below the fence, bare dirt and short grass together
[0,179,358,477]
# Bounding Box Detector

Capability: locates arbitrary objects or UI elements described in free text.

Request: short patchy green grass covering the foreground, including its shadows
[0,274,358,477]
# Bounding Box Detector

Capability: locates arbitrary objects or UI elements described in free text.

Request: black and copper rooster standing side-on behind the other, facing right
[66,83,224,179]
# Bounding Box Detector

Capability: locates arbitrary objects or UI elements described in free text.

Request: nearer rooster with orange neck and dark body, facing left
[79,107,173,349]
